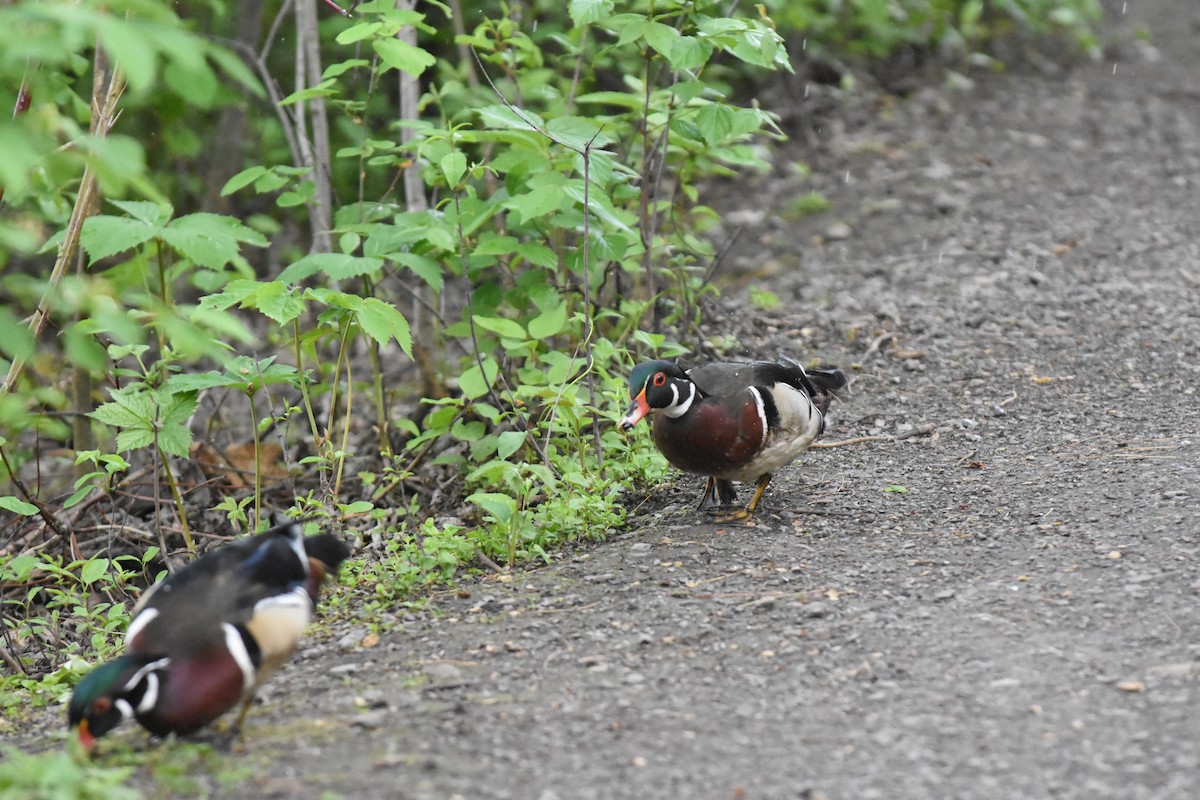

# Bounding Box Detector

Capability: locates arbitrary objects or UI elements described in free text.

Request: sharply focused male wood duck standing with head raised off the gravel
[620,357,846,522]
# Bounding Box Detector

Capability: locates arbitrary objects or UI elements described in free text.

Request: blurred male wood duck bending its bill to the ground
[67,523,349,750]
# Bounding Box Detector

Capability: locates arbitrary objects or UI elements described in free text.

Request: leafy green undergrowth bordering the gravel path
[0,0,1098,796]
